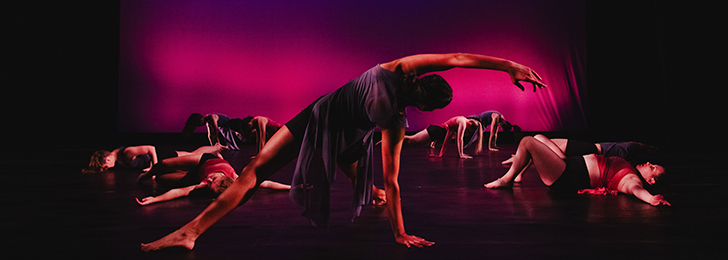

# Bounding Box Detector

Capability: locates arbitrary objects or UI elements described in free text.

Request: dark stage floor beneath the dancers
[1,137,728,259]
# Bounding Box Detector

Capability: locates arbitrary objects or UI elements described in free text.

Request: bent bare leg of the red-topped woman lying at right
[485,136,566,188]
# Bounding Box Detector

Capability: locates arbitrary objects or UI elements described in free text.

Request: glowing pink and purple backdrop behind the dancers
[119,0,586,133]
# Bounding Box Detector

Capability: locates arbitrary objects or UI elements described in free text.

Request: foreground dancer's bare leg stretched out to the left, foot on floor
[141,126,300,252]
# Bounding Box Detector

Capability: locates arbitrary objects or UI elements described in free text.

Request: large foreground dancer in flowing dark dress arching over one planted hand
[141,53,545,251]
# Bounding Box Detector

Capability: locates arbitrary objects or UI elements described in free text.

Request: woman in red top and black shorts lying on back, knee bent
[485,136,670,206]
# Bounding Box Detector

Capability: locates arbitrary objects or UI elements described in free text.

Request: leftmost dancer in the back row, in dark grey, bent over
[182,113,246,150]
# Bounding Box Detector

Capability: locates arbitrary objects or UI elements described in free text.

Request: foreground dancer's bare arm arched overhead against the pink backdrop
[382,53,546,91]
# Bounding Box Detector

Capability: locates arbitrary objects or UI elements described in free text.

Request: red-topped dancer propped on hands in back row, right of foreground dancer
[404,116,483,159]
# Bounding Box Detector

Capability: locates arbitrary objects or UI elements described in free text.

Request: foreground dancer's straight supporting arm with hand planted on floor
[382,128,434,247]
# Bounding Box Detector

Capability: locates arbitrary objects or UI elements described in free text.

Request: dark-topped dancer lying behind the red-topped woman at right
[503,134,657,182]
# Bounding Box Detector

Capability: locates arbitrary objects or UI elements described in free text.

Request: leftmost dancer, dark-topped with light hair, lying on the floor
[83,144,225,173]
